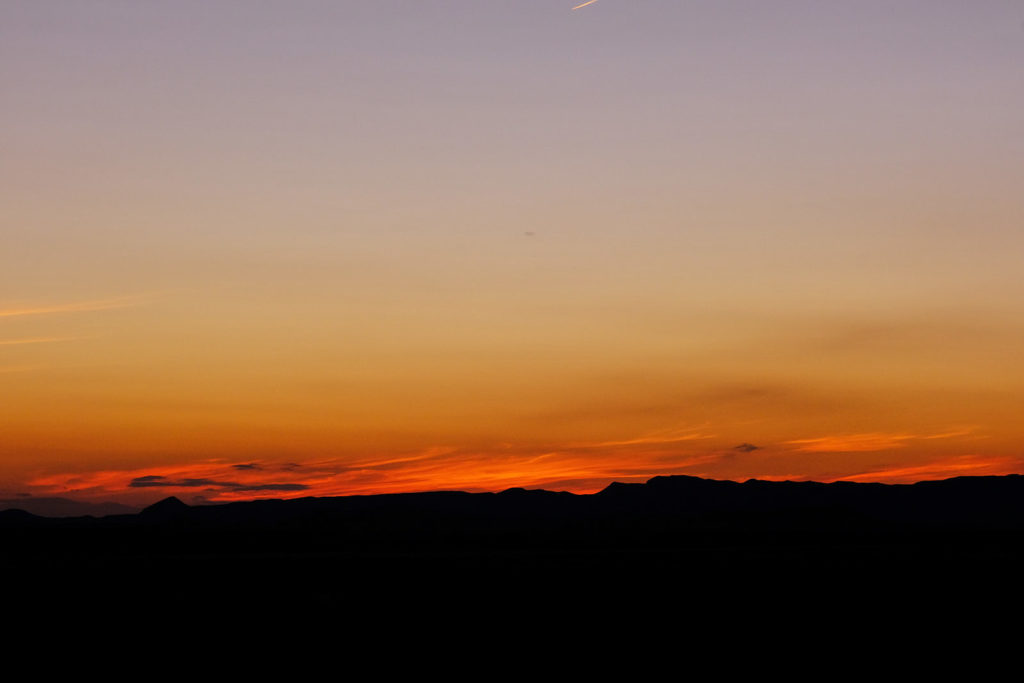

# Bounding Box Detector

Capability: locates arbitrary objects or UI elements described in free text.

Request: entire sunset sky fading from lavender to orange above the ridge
[0,0,1024,505]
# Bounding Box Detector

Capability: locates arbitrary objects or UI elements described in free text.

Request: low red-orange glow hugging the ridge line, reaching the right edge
[19,436,1022,504]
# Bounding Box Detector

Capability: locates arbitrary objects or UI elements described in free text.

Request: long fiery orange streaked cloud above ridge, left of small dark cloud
[27,437,721,502]
